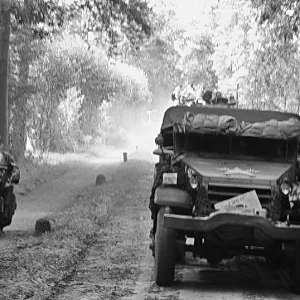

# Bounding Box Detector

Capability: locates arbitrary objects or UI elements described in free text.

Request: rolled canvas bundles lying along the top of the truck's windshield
[174,112,300,139]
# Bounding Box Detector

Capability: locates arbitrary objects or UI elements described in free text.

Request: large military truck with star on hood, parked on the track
[149,106,300,293]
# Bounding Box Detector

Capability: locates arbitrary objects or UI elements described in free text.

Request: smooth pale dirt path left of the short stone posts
[5,151,122,233]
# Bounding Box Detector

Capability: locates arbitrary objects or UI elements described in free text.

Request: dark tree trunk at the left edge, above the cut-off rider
[0,0,10,150]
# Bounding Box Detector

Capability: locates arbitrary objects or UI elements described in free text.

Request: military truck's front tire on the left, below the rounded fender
[154,207,175,286]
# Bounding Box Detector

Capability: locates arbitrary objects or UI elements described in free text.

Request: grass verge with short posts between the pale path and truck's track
[0,161,154,300]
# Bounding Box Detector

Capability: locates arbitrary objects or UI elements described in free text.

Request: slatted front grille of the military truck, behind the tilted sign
[208,185,271,208]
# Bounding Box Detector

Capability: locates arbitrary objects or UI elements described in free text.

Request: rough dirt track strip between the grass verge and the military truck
[52,162,152,300]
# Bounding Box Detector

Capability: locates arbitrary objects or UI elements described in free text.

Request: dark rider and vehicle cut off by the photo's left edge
[0,145,20,231]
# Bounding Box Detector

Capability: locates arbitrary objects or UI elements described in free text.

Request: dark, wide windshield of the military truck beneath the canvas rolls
[184,133,299,161]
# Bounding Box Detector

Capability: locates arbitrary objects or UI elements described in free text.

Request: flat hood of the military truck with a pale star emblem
[182,157,294,186]
